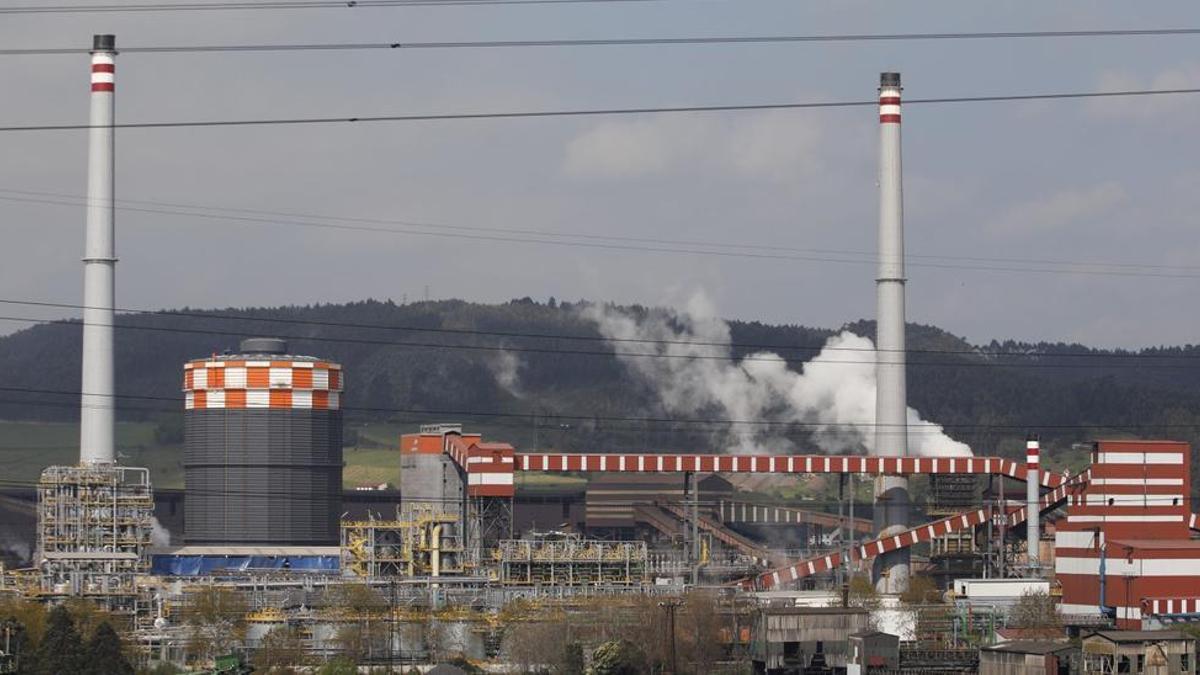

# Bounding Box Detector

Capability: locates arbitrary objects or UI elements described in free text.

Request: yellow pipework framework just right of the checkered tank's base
[341,507,464,578]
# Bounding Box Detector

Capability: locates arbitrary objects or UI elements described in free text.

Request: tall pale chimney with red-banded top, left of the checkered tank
[79,35,116,464]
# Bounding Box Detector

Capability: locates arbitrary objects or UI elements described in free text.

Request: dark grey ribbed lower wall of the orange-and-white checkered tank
[184,408,342,545]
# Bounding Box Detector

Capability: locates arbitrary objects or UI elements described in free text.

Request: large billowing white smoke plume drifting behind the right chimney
[583,294,971,456]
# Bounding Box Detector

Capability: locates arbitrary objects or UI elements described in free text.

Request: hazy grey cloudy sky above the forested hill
[0,0,1200,347]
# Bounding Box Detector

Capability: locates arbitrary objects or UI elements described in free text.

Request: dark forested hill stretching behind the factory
[0,298,1200,453]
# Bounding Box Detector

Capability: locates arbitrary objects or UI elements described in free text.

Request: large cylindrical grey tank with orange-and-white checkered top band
[184,338,343,545]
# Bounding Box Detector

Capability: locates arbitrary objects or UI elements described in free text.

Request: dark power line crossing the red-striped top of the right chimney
[0,88,1200,132]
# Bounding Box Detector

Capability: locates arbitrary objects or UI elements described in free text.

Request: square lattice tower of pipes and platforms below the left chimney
[37,464,154,610]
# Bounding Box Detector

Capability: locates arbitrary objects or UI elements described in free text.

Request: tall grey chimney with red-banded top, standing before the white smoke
[875,72,910,593]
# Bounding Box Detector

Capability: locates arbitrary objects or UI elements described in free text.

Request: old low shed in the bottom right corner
[1082,631,1196,675]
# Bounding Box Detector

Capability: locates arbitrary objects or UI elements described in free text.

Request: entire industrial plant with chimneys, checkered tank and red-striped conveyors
[0,35,1200,675]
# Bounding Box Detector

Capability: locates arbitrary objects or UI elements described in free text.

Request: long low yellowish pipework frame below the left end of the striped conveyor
[496,536,647,586]
